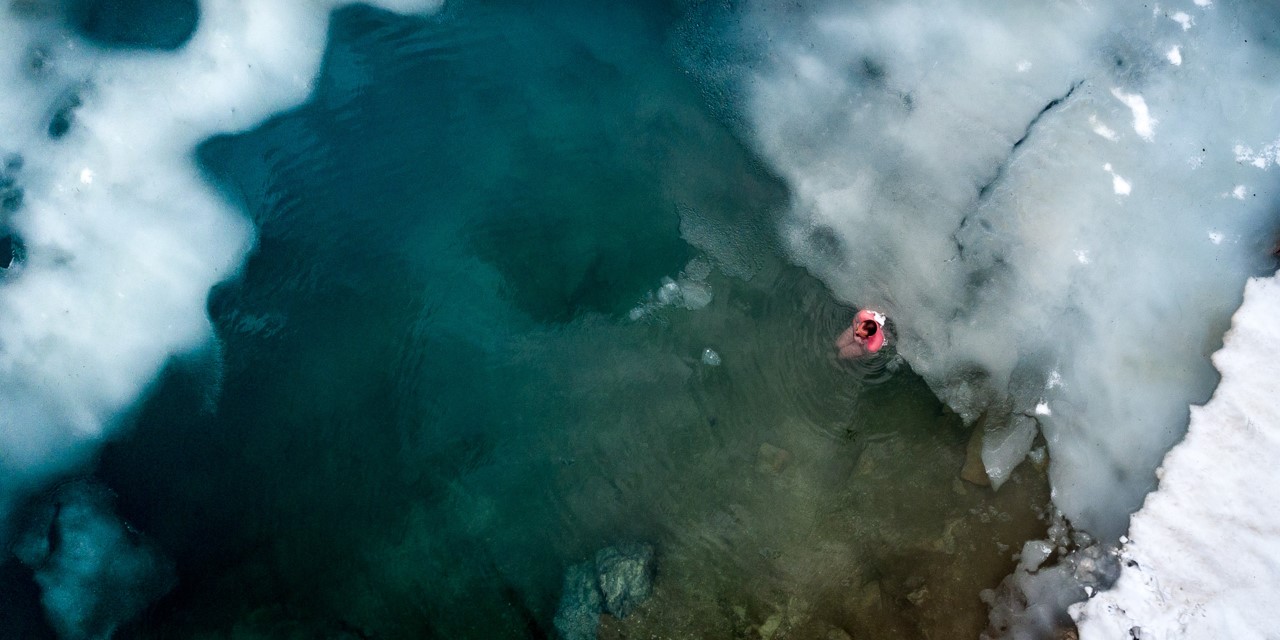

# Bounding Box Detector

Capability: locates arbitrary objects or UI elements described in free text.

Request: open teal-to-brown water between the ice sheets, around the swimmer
[10,1,1047,637]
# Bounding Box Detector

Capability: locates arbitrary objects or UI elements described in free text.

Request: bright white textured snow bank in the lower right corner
[1071,278,1280,640]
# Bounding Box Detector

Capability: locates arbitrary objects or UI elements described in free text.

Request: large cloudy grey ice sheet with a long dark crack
[737,0,1280,540]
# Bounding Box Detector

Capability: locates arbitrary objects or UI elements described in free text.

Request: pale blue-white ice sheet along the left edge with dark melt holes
[0,0,436,539]
